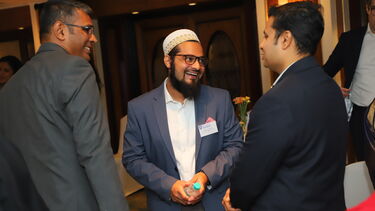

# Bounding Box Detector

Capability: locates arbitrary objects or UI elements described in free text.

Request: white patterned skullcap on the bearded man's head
[163,29,200,55]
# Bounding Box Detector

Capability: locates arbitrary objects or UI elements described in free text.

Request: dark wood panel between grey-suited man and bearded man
[99,17,140,152]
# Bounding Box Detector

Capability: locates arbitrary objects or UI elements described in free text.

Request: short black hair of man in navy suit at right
[268,1,324,55]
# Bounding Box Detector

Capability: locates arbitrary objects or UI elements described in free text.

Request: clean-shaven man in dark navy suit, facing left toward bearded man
[222,2,348,211]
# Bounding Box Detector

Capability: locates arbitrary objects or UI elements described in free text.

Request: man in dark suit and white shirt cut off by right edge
[323,0,375,162]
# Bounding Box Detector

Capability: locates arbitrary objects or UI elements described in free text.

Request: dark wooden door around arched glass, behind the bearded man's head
[136,1,262,101]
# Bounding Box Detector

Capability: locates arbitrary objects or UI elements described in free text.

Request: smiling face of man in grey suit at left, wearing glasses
[64,9,97,60]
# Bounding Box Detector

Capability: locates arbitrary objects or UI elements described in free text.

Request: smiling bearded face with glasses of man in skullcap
[165,41,205,98]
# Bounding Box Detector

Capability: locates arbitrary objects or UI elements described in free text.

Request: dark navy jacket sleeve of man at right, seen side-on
[230,97,296,210]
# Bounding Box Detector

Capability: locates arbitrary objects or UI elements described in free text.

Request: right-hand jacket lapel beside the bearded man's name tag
[194,86,207,159]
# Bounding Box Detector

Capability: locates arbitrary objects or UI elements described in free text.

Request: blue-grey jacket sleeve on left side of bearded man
[122,103,177,201]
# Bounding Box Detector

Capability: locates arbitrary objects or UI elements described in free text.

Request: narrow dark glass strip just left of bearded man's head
[151,40,168,88]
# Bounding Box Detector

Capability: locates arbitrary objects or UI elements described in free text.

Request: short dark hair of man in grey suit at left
[39,0,94,37]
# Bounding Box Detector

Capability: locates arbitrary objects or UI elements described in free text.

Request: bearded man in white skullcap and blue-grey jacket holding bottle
[123,29,242,211]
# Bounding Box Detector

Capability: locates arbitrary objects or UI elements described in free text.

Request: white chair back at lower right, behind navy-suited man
[344,161,374,208]
